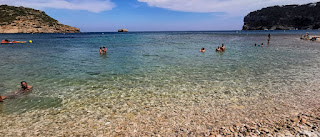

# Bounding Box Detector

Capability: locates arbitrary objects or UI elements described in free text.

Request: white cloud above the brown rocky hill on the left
[0,0,115,13]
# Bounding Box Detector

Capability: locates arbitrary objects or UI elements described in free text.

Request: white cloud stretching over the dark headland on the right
[138,0,319,15]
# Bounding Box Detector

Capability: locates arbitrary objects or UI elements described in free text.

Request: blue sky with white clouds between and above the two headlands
[0,0,319,32]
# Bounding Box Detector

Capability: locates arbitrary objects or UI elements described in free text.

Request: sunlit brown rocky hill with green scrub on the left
[0,5,80,33]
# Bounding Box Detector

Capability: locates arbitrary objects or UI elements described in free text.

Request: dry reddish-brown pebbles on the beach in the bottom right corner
[208,108,320,137]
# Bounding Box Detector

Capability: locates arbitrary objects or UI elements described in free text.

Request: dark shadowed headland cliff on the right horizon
[242,2,320,30]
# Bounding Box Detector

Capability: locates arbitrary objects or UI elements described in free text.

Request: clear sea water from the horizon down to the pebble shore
[0,31,320,135]
